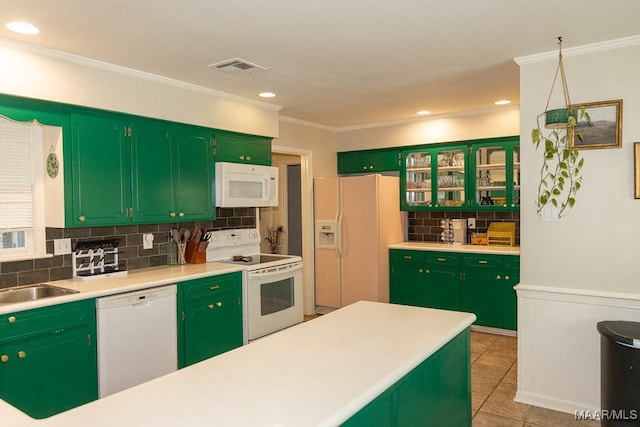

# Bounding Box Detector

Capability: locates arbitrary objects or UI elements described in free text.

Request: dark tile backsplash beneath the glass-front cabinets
[408,211,520,245]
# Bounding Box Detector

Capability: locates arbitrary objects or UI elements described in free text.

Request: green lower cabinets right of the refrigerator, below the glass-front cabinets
[389,249,520,330]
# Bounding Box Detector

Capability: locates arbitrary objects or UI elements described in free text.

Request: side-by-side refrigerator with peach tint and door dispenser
[314,175,405,312]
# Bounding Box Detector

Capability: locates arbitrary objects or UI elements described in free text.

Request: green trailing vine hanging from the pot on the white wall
[531,108,591,218]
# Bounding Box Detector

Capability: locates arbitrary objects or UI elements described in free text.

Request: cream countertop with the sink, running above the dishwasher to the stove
[0,262,242,314]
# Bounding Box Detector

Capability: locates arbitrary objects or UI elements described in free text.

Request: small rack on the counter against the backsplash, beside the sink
[71,239,127,280]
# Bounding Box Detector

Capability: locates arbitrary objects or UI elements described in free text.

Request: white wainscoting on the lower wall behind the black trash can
[515,284,640,413]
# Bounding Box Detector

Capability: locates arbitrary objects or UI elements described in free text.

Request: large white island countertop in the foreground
[0,301,475,427]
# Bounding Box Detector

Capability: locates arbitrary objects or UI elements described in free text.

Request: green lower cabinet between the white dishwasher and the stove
[178,272,243,368]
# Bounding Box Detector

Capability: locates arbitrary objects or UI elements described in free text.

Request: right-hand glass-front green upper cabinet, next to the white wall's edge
[471,141,520,210]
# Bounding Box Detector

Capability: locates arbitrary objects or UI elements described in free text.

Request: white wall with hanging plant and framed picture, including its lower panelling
[516,37,640,412]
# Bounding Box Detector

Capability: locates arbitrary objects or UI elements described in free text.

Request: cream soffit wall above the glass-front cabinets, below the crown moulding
[336,106,520,151]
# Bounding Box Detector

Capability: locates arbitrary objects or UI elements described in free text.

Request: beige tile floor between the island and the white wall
[471,331,600,427]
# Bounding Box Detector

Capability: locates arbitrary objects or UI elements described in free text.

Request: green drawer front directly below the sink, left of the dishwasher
[0,299,95,343]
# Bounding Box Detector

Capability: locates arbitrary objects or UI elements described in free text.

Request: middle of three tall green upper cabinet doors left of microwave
[131,119,175,224]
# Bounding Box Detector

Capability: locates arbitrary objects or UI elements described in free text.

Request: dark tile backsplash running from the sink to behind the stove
[0,208,256,288]
